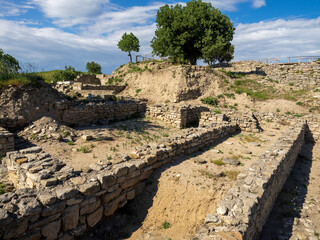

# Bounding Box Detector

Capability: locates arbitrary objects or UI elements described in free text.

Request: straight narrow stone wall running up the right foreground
[195,123,307,240]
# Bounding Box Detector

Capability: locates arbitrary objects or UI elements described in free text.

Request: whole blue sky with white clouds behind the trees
[0,0,320,74]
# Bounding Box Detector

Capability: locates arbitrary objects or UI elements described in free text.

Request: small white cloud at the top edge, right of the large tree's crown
[206,0,266,11]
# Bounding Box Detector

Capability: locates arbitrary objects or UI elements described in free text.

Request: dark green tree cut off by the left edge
[0,49,20,80]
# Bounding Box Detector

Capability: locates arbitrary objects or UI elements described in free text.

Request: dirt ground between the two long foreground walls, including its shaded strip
[79,123,287,240]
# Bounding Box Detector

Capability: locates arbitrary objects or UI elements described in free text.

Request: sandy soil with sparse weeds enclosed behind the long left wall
[31,118,183,171]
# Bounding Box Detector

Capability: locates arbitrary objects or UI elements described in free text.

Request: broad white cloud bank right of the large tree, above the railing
[233,17,320,60]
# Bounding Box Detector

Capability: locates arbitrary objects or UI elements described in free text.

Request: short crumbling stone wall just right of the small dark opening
[199,109,261,132]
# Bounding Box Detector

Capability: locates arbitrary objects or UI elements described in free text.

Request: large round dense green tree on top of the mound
[151,0,235,65]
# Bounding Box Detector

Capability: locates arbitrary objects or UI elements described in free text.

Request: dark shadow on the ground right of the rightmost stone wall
[259,133,315,240]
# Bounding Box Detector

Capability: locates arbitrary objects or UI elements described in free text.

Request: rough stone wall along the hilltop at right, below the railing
[223,61,320,89]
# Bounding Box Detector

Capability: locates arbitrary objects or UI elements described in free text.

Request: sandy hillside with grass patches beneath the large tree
[112,62,318,113]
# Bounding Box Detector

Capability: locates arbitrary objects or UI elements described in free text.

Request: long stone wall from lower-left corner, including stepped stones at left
[0,125,237,239]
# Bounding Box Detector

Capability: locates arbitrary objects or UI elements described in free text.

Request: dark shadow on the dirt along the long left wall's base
[77,131,240,240]
